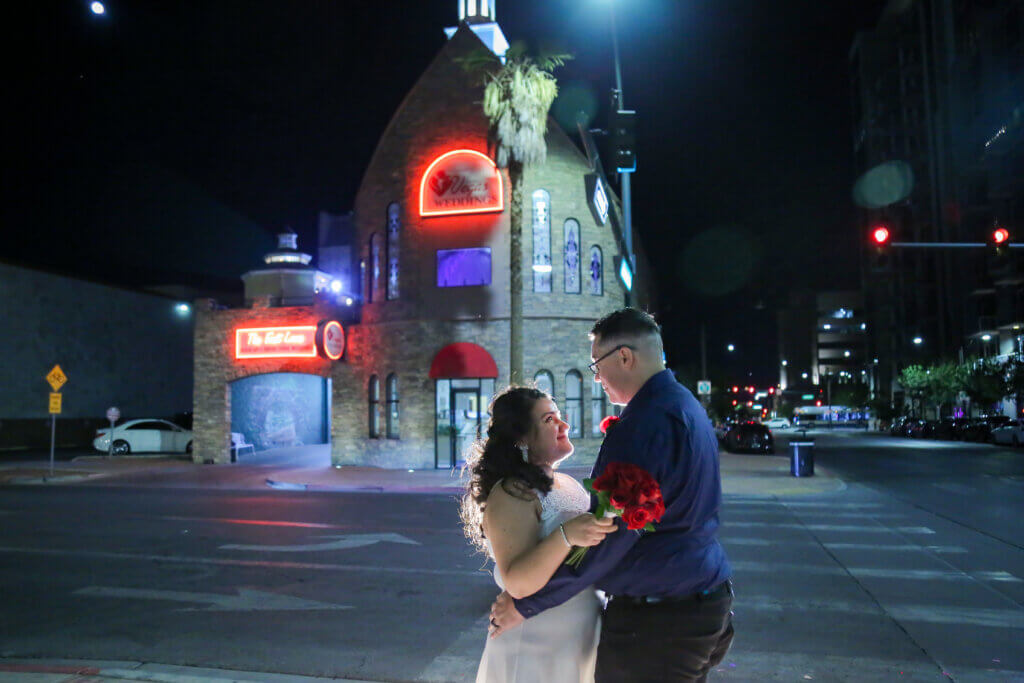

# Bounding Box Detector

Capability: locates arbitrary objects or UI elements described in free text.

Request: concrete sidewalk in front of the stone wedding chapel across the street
[0,449,845,497]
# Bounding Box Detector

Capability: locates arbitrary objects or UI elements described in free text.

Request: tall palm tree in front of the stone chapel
[464,45,572,384]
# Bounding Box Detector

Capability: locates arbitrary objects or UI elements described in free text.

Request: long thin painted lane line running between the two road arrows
[0,546,494,583]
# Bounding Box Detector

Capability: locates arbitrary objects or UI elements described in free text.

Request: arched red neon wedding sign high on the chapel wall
[420,150,505,216]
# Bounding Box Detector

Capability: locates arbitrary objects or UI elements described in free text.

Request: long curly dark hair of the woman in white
[459,386,554,552]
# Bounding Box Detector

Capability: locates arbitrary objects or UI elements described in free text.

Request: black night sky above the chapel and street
[8,0,884,382]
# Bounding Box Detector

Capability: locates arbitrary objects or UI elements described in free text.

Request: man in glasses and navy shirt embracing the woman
[492,308,733,683]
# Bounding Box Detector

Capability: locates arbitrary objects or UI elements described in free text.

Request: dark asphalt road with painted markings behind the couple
[0,435,1024,681]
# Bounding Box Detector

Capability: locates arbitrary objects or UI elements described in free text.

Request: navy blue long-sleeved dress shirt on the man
[515,370,732,617]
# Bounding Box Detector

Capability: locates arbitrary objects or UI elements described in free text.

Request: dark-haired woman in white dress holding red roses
[461,387,615,683]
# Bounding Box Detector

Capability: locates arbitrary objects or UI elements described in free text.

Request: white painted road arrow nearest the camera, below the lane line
[74,586,352,611]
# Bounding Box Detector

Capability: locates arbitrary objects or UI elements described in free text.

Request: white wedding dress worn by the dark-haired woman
[476,476,601,683]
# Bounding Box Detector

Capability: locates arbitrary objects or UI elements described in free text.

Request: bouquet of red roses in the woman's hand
[565,463,665,567]
